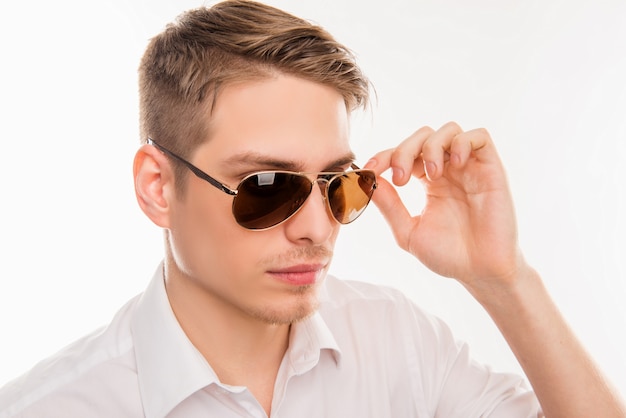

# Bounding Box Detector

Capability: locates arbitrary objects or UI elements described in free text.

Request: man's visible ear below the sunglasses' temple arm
[133,144,175,228]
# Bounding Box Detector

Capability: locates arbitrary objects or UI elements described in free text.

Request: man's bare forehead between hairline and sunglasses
[195,75,354,172]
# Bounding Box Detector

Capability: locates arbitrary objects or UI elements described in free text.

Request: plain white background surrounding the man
[0,0,626,394]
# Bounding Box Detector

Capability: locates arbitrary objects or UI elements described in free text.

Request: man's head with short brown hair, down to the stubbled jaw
[134,1,374,324]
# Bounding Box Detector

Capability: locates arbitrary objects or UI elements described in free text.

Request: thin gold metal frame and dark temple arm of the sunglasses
[147,137,378,231]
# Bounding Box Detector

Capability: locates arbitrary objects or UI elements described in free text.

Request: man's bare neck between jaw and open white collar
[166,262,290,415]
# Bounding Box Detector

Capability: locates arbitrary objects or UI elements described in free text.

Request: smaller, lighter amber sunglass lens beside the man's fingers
[328,170,376,224]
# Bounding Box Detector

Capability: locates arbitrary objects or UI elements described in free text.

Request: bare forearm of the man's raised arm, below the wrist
[470,268,626,418]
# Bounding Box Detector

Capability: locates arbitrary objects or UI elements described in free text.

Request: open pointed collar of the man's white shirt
[131,263,341,418]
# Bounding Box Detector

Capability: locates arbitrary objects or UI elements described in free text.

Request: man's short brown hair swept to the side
[139,0,369,171]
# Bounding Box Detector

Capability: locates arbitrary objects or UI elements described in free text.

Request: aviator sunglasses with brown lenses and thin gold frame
[148,138,377,230]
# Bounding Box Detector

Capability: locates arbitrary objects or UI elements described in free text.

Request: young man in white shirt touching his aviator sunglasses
[0,1,626,418]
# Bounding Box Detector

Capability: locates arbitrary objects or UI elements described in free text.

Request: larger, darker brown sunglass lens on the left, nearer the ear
[233,172,313,229]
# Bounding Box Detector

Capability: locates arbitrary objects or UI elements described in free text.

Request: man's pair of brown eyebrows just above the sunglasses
[222,152,356,172]
